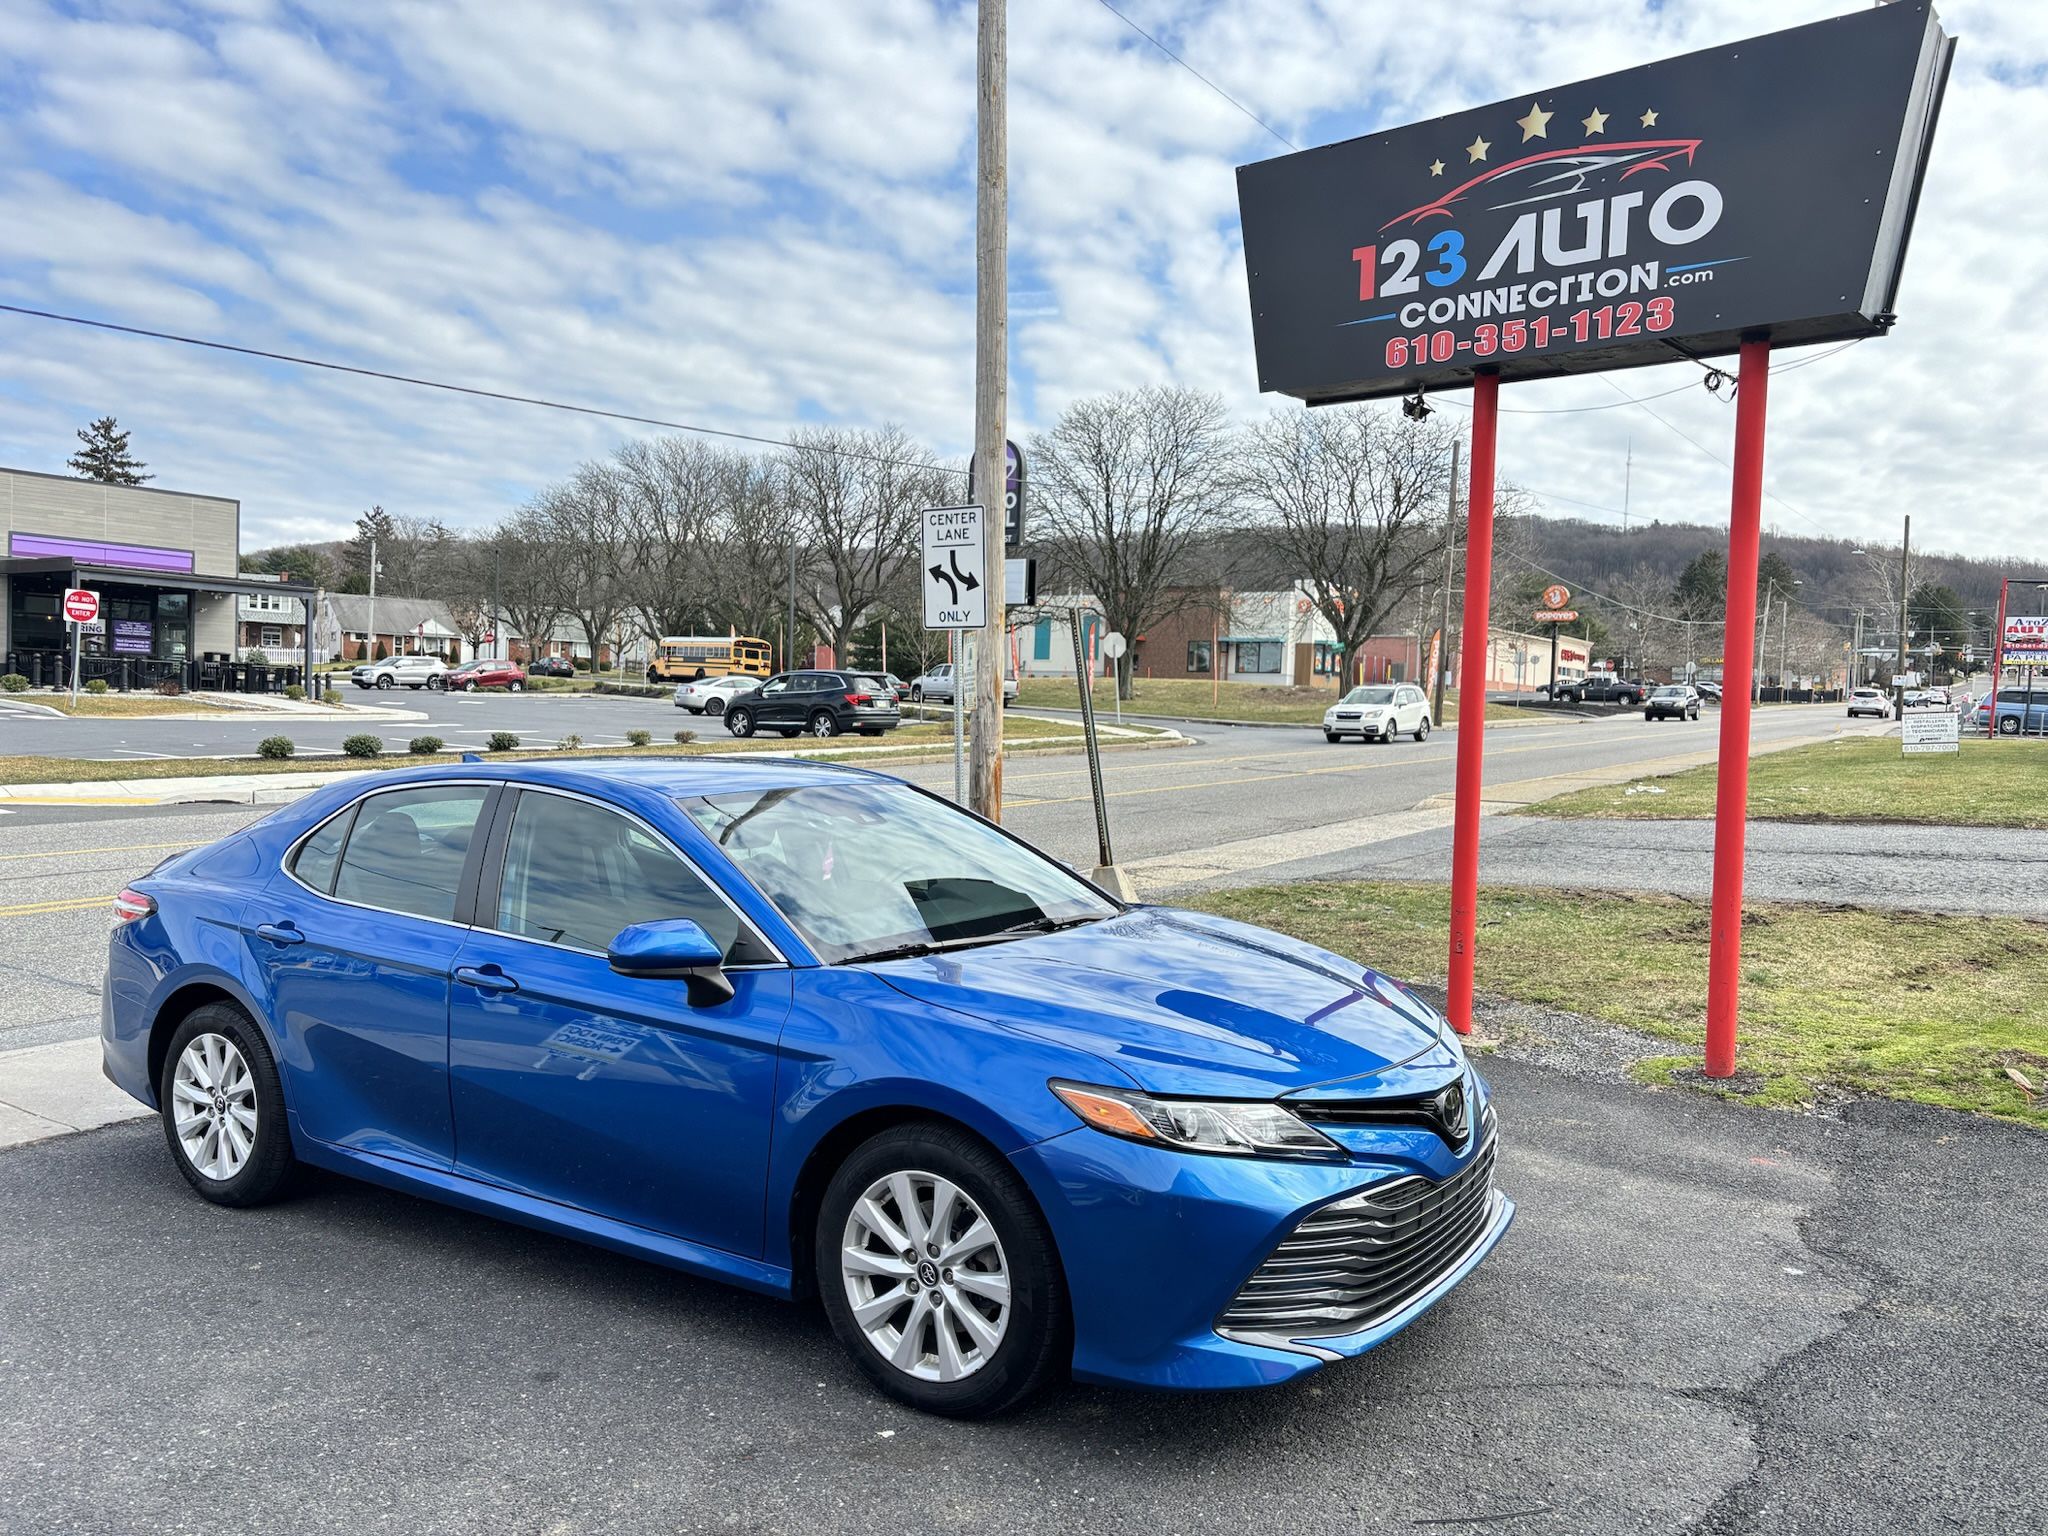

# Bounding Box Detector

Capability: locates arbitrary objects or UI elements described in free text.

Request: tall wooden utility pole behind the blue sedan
[970,0,1010,821]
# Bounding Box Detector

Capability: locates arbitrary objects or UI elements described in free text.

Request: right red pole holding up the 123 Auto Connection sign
[1706,338,1772,1077]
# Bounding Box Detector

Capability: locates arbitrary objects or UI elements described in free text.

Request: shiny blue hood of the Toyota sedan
[874,907,1450,1098]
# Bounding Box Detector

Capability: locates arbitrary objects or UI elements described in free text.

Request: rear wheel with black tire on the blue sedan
[156,1004,295,1206]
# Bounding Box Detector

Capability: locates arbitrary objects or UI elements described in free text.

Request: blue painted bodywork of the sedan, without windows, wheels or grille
[102,760,1513,1386]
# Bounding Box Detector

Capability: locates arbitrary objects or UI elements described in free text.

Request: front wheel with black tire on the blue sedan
[813,1124,1073,1419]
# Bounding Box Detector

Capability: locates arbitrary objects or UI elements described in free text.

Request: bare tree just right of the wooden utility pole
[1032,385,1235,698]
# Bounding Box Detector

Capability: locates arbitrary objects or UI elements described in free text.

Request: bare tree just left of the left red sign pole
[1237,410,1456,684]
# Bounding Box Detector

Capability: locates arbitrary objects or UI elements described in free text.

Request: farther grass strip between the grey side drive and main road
[1524,735,2048,827]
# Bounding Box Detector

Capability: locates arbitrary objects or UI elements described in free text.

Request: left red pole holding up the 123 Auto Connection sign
[1448,373,1501,1034]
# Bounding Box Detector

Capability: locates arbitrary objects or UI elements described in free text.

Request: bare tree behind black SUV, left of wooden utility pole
[780,424,944,657]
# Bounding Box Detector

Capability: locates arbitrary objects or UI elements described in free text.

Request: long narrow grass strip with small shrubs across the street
[0,719,1155,784]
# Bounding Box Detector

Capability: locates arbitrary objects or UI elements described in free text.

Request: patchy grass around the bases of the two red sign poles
[1194,883,2048,1128]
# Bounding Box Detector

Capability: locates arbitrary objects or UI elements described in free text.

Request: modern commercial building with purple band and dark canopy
[0,469,313,688]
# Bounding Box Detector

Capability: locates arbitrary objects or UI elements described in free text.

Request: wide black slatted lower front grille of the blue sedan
[1217,1106,1499,1337]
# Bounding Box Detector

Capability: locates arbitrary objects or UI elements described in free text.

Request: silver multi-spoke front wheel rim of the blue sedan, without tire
[840,1169,1010,1382]
